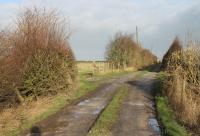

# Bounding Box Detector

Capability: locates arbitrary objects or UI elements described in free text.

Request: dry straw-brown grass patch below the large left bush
[0,98,52,135]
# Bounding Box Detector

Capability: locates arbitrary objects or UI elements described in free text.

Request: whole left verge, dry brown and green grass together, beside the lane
[0,72,133,136]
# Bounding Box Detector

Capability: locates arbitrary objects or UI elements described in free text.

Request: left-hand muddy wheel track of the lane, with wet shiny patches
[22,74,134,136]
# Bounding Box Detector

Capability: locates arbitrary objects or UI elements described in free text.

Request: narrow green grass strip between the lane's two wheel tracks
[88,86,128,136]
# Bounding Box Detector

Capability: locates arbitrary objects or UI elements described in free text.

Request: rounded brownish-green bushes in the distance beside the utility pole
[106,33,157,69]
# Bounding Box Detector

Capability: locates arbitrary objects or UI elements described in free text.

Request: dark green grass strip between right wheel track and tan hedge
[154,73,188,136]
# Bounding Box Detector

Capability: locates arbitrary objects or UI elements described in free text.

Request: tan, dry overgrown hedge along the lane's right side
[161,37,200,135]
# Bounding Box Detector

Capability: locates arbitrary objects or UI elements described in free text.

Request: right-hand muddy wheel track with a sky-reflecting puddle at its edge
[112,73,160,136]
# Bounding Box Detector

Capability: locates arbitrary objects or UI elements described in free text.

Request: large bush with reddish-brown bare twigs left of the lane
[0,8,76,107]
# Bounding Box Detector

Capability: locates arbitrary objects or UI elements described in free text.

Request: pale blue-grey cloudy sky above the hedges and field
[0,0,200,60]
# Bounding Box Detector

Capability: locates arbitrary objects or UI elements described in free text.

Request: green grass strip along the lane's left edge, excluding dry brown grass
[0,71,133,136]
